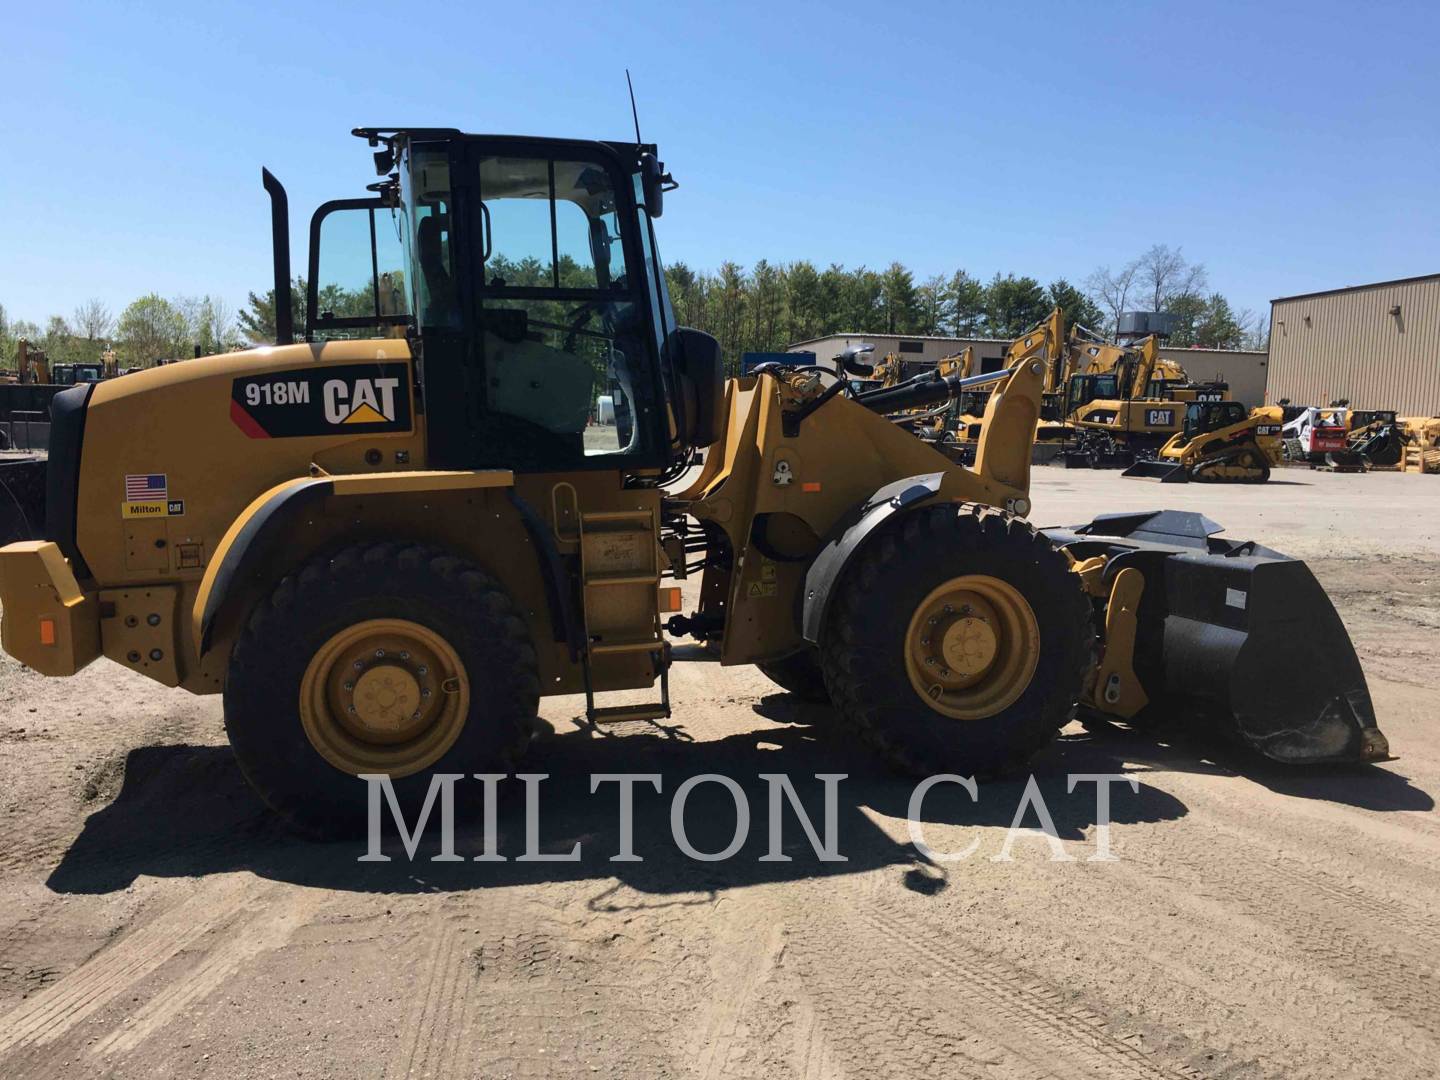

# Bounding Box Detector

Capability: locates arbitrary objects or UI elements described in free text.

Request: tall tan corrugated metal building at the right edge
[1267,274,1440,416]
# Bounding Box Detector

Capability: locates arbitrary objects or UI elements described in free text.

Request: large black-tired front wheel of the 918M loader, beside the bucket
[821,505,1096,776]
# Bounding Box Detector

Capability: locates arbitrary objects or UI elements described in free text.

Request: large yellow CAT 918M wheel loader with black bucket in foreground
[0,128,1388,832]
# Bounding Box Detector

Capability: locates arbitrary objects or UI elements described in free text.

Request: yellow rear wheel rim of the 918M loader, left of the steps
[300,619,469,778]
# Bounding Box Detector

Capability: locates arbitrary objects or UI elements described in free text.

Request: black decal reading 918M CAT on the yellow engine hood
[230,364,410,439]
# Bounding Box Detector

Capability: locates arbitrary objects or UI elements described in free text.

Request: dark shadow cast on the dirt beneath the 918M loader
[48,714,1188,894]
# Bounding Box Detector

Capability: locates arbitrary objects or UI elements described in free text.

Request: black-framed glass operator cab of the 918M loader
[293,128,720,474]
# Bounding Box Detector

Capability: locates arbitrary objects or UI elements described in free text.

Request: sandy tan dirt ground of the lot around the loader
[0,468,1440,1079]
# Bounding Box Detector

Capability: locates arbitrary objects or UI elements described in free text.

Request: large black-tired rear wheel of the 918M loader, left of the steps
[225,543,540,837]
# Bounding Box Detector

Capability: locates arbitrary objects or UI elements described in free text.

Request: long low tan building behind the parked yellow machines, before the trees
[789,334,1269,408]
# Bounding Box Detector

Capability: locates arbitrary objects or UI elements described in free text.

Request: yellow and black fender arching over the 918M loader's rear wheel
[190,469,577,657]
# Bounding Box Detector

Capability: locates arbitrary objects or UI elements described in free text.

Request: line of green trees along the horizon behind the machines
[8,243,1269,367]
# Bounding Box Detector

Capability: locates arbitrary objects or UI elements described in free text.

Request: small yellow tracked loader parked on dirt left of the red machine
[1120,402,1270,484]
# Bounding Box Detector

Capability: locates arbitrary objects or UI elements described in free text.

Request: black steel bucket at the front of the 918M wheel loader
[1045,510,1390,765]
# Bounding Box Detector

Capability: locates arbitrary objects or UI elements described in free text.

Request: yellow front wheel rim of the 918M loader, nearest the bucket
[904,575,1040,720]
